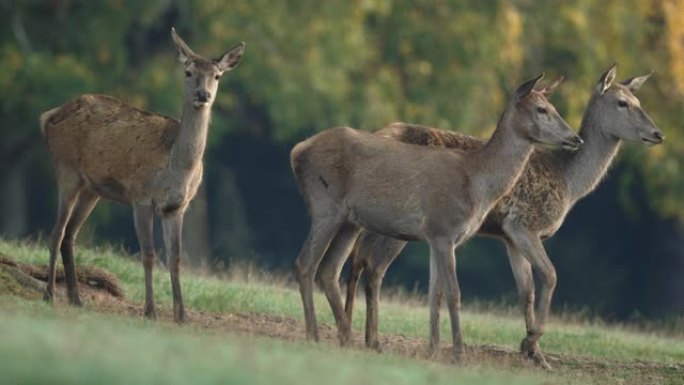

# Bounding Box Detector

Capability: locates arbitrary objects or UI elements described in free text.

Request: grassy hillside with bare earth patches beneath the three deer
[0,240,684,384]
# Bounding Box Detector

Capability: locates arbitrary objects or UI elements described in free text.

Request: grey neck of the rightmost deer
[564,97,620,202]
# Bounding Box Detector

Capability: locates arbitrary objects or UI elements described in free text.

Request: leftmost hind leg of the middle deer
[295,215,344,341]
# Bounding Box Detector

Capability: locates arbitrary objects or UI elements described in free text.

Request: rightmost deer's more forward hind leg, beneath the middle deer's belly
[364,234,406,351]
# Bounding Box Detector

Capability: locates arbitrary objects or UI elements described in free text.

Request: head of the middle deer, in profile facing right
[513,73,582,150]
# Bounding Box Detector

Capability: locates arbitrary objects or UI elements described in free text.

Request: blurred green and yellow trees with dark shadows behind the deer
[0,0,684,318]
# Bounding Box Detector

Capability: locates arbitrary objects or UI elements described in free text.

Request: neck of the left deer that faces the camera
[169,103,211,171]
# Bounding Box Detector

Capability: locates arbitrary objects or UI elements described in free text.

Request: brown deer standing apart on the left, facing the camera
[40,28,245,323]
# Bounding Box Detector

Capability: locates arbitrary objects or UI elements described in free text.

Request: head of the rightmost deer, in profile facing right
[594,63,665,145]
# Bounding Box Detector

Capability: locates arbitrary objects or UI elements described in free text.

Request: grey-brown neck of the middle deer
[470,109,533,204]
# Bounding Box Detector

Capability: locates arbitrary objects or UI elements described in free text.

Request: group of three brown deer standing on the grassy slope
[40,29,664,368]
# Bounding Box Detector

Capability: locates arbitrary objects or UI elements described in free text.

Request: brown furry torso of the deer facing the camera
[42,95,179,201]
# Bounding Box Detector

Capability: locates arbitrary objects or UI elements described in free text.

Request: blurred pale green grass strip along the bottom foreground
[0,296,542,385]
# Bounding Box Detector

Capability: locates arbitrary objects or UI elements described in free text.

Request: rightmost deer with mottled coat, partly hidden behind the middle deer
[345,64,665,369]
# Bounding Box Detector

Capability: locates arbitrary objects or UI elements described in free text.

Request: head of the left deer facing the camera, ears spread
[171,28,245,109]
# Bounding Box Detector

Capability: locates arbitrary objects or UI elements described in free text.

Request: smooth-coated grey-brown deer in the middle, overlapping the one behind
[290,73,582,360]
